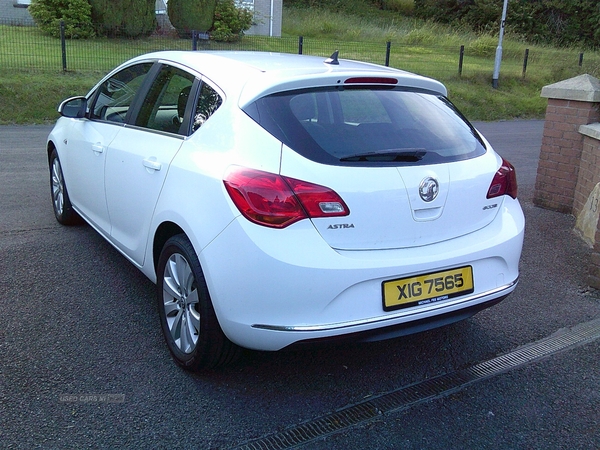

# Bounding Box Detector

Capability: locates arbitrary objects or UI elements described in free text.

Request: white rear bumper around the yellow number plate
[199,199,524,350]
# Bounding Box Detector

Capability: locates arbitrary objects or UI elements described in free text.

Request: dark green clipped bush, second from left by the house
[90,0,156,37]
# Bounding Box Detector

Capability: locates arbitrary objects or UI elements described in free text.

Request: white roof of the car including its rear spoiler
[126,51,447,107]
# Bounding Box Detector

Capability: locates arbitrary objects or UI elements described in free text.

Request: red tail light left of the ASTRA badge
[223,167,350,228]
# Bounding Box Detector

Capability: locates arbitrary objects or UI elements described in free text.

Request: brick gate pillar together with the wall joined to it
[533,75,600,289]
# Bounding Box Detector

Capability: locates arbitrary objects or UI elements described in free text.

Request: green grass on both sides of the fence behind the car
[0,8,600,124]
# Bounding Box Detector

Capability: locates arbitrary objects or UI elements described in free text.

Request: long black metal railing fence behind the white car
[0,21,600,80]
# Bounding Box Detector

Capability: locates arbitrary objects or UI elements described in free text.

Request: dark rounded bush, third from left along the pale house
[167,0,217,37]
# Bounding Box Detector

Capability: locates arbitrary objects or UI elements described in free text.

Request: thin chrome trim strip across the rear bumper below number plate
[252,278,519,332]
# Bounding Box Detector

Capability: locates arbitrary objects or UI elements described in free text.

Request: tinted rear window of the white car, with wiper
[244,86,485,165]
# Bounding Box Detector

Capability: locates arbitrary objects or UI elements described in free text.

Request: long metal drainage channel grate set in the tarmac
[235,319,600,450]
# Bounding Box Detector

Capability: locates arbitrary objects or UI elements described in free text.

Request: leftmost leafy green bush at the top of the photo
[29,0,94,39]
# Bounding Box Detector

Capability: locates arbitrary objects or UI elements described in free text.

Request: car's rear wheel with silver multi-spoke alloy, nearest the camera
[156,234,241,371]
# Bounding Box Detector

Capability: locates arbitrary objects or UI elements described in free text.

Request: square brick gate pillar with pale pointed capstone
[533,75,600,214]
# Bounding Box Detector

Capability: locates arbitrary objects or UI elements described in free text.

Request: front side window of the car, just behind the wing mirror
[90,63,153,123]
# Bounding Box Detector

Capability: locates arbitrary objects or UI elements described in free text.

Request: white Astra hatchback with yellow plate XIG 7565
[47,52,524,370]
